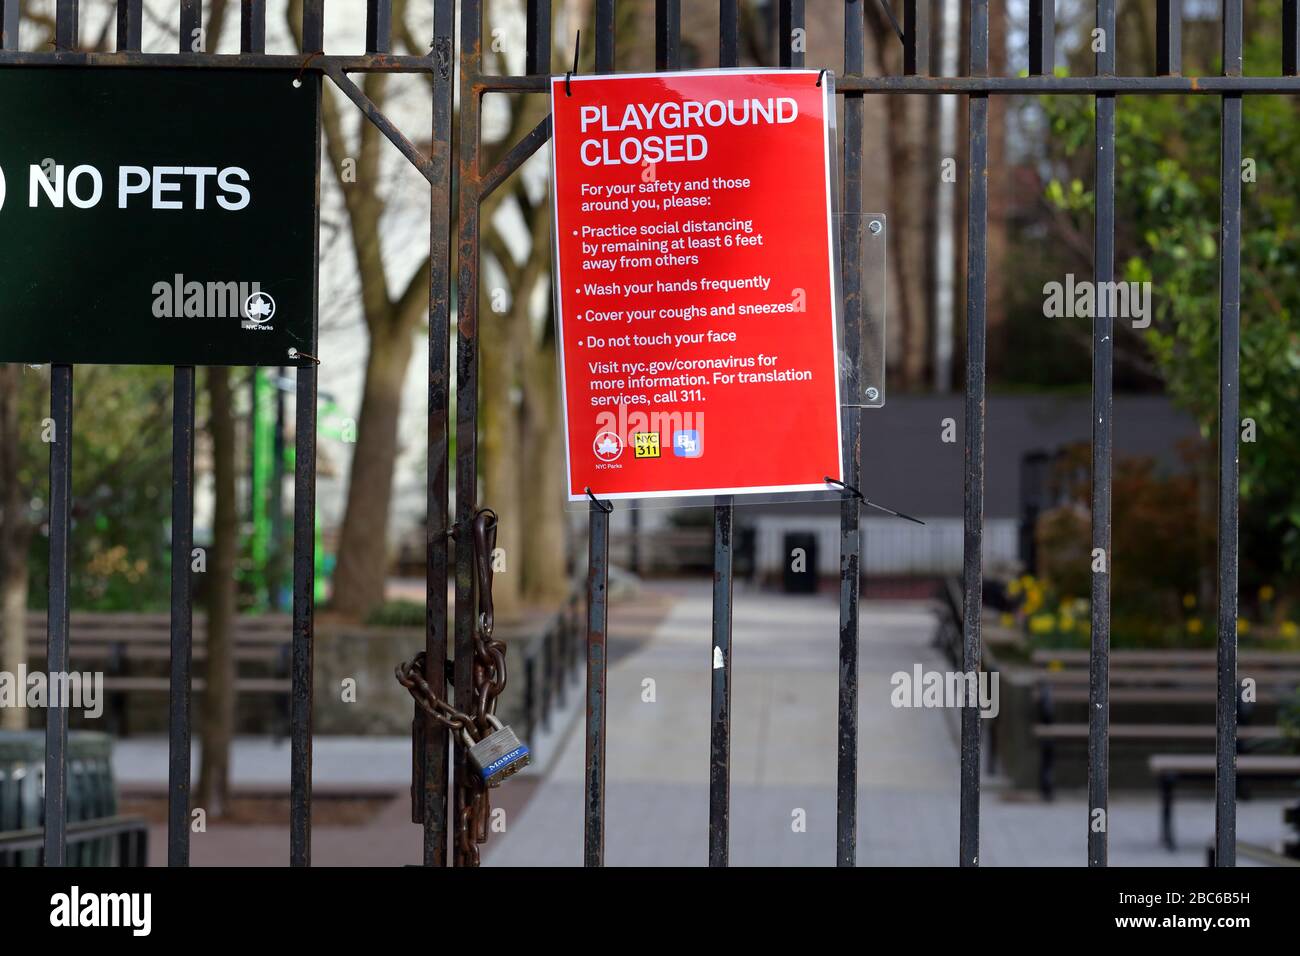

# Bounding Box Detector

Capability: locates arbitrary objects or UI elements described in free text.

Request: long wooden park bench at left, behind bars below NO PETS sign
[27,611,293,736]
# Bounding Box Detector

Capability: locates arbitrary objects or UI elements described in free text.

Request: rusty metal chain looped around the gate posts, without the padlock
[397,509,506,866]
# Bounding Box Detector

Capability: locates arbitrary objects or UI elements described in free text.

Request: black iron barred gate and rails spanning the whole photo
[0,0,1279,866]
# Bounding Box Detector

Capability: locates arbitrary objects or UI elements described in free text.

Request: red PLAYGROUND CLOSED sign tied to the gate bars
[551,70,844,501]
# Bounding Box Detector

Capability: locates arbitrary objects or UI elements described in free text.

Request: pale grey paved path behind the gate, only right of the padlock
[485,583,1282,866]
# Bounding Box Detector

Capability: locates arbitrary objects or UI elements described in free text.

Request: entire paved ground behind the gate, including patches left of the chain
[114,581,1283,866]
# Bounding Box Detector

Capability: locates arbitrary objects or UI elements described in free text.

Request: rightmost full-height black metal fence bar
[1214,0,1243,866]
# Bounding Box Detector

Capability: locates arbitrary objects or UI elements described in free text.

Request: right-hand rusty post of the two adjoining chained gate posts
[451,0,482,866]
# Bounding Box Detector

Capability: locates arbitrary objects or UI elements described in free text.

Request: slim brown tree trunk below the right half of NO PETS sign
[196,368,239,818]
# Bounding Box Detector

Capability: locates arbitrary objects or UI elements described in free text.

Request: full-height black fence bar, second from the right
[1087,0,1115,866]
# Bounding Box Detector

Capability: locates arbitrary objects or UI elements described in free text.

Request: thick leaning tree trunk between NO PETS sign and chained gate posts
[332,324,415,618]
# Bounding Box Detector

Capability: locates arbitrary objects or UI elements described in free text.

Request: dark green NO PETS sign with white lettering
[0,66,321,365]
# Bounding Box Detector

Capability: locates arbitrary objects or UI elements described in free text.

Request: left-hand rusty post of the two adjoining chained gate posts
[423,0,456,866]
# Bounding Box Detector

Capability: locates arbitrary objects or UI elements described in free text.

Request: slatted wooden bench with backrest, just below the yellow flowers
[1031,649,1300,799]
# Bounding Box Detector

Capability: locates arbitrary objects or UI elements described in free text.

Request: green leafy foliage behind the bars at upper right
[1040,20,1300,576]
